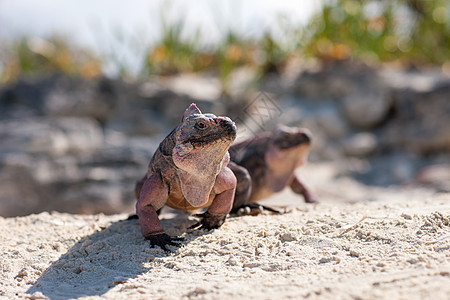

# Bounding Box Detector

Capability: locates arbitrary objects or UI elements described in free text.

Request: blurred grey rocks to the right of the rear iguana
[263,61,450,185]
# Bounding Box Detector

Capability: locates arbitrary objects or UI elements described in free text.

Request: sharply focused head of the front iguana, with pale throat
[172,104,236,178]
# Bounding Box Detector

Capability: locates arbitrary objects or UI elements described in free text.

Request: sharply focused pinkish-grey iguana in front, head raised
[135,104,236,251]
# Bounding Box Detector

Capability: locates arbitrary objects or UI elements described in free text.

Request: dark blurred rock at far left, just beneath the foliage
[0,76,118,123]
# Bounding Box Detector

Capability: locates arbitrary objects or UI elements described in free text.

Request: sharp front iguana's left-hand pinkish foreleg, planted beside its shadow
[136,173,181,251]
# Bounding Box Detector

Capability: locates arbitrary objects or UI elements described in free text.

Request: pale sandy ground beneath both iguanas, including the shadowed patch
[0,166,450,299]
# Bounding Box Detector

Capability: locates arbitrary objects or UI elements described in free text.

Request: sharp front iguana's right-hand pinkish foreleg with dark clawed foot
[191,167,236,230]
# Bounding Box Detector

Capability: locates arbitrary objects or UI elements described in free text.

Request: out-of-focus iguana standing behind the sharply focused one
[229,126,317,214]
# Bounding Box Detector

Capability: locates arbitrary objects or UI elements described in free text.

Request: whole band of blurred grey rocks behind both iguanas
[0,62,450,216]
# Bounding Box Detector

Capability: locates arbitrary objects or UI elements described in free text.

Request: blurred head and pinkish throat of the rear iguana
[265,126,311,191]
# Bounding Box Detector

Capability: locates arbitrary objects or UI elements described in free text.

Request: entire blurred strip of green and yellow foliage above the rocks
[0,0,450,86]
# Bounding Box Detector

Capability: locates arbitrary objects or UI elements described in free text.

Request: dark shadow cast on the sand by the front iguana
[27,216,199,299]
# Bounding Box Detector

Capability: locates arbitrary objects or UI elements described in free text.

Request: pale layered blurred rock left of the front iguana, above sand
[0,118,160,216]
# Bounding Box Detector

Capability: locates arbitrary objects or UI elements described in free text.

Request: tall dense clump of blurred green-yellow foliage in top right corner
[304,0,450,65]
